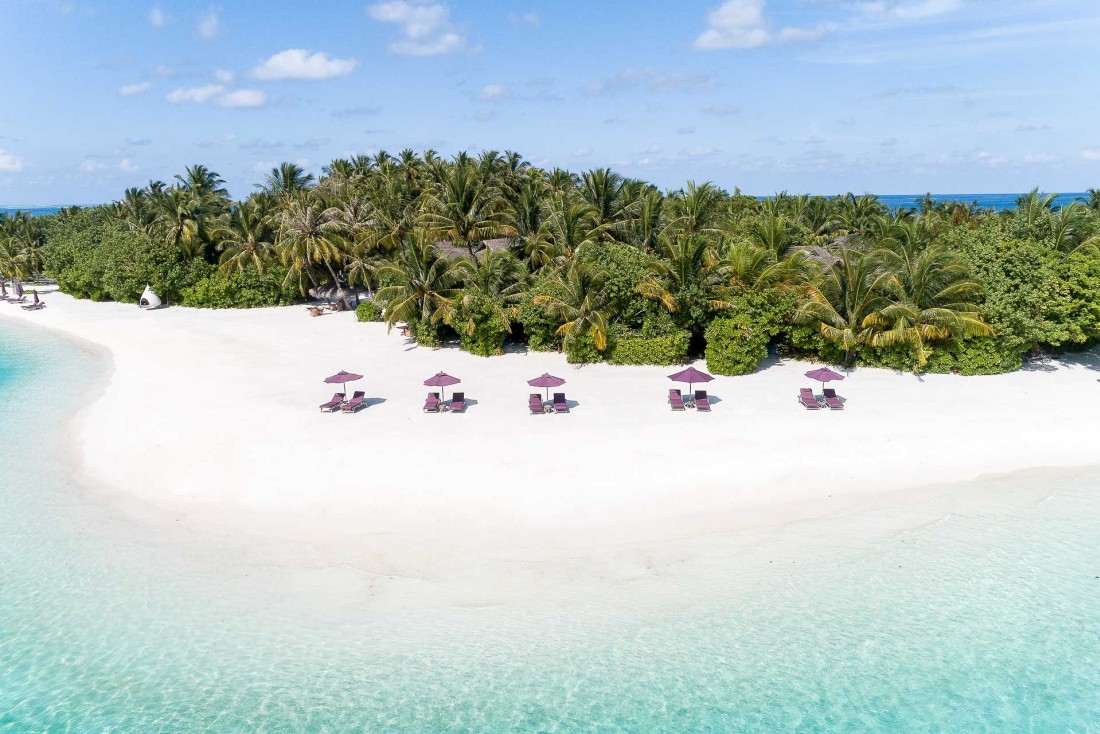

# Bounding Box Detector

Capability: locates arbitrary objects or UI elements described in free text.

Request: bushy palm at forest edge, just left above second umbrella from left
[377,234,462,327]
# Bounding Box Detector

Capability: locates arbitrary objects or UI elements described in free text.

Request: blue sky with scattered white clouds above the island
[0,0,1100,205]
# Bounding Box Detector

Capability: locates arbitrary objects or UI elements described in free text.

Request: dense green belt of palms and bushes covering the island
[0,151,1100,374]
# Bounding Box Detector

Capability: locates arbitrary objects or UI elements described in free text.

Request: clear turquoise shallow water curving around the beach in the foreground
[0,320,1100,734]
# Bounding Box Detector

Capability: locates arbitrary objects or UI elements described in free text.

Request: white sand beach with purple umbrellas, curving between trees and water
[0,294,1100,598]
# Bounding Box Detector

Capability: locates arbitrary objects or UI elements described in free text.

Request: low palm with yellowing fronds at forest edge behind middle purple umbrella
[532,260,612,351]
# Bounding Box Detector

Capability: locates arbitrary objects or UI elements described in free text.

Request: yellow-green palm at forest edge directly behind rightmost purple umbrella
[794,247,890,364]
